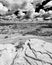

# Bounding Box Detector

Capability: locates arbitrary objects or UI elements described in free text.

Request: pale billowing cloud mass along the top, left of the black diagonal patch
[0,0,47,16]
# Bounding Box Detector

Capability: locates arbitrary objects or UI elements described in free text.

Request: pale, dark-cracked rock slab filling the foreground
[0,38,52,65]
